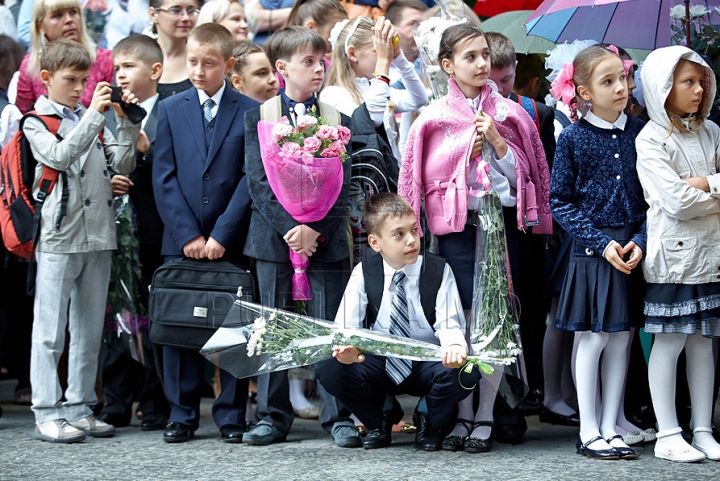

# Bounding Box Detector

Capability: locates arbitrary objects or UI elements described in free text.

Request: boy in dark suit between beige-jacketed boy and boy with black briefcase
[98,35,170,430]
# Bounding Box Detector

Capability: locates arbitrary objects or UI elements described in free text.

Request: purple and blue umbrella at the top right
[525,0,720,50]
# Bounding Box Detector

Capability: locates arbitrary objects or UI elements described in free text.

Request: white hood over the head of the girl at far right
[640,45,716,129]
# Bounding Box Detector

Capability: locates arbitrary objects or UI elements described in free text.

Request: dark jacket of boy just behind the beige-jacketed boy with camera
[105,101,163,245]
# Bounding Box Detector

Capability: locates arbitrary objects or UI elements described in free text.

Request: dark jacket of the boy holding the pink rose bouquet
[245,98,351,262]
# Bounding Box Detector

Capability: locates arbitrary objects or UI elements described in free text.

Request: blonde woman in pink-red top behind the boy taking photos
[15,0,114,113]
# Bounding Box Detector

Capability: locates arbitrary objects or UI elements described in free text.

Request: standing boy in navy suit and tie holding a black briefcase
[153,23,257,442]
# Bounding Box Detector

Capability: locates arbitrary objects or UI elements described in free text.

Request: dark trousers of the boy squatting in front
[315,354,480,432]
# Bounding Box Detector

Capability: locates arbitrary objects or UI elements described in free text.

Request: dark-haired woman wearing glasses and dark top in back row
[149,0,200,98]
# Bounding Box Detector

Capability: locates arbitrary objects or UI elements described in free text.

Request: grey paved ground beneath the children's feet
[0,381,720,481]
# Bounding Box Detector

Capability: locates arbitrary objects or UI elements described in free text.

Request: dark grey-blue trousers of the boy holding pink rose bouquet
[256,259,350,434]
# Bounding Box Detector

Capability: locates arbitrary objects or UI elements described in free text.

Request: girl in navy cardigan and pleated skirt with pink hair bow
[550,46,647,459]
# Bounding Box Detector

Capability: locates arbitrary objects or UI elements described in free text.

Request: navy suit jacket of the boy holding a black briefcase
[153,84,258,257]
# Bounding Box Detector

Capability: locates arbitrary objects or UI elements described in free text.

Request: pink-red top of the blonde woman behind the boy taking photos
[15,47,115,113]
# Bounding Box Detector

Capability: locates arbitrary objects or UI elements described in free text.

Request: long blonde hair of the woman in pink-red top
[26,0,97,77]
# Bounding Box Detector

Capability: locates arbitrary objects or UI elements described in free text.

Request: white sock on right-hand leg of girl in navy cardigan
[600,331,630,447]
